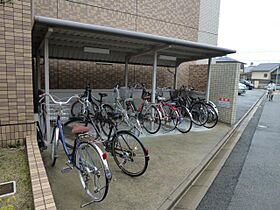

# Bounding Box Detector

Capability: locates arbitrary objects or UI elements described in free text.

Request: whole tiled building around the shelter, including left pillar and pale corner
[0,0,235,146]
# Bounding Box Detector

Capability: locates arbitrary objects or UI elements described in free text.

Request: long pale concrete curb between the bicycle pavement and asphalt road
[158,93,265,209]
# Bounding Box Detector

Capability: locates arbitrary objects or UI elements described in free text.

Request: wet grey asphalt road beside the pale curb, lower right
[197,95,280,210]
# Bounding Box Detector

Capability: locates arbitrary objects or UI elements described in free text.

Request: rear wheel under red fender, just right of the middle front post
[161,104,179,132]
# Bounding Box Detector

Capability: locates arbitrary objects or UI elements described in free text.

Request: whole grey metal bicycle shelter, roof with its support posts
[32,16,235,139]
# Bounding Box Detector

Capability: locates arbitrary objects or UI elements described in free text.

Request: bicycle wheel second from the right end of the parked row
[190,102,208,126]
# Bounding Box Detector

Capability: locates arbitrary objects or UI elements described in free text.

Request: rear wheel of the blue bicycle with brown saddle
[75,142,110,202]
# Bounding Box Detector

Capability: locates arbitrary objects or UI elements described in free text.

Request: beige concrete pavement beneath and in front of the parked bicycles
[42,89,266,209]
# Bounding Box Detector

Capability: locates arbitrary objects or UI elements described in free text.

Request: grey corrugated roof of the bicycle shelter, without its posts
[32,16,235,67]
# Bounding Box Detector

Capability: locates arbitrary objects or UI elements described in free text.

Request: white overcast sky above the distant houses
[218,0,280,65]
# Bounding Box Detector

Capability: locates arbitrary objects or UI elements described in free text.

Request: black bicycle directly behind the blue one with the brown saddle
[64,92,149,177]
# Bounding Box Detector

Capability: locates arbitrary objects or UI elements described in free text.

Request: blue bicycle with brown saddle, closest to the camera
[41,94,112,208]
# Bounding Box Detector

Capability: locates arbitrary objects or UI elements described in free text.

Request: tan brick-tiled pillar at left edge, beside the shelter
[0,0,34,147]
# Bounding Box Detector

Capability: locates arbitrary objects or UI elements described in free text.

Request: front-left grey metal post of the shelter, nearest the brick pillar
[44,38,51,141]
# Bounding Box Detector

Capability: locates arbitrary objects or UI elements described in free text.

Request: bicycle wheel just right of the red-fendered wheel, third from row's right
[176,105,193,133]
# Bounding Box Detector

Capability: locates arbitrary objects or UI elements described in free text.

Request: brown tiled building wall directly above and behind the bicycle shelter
[34,0,200,88]
